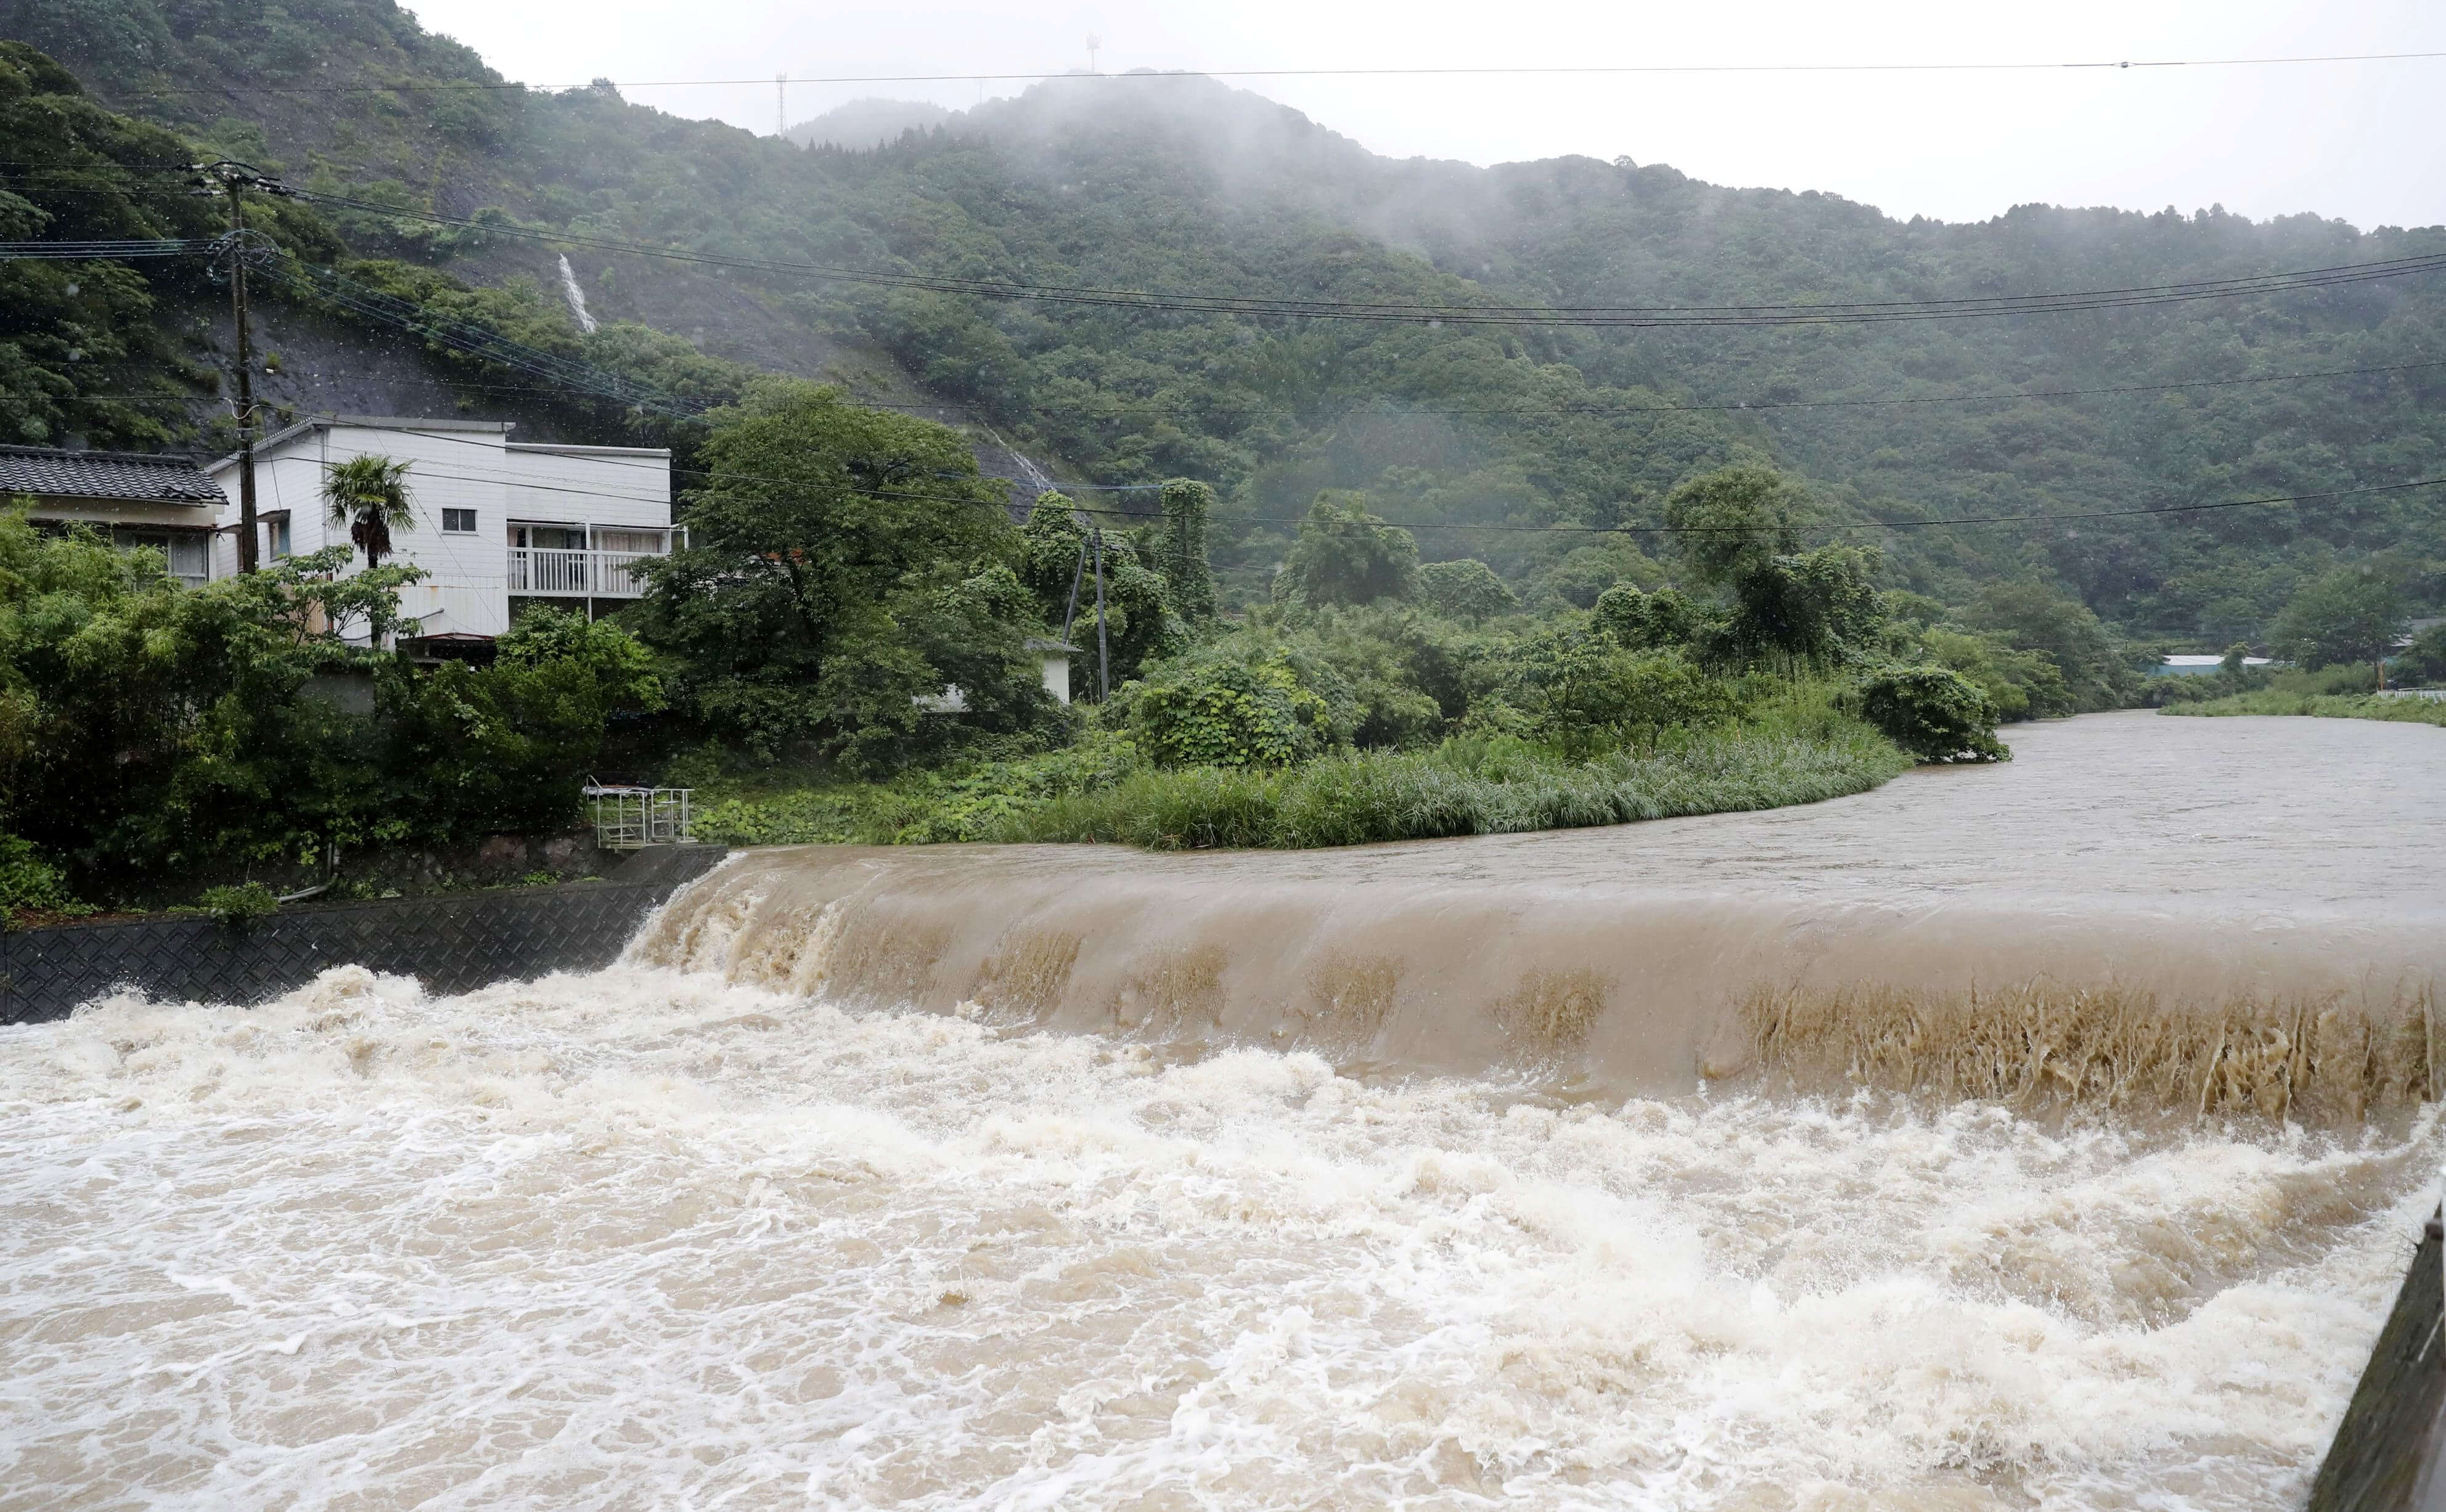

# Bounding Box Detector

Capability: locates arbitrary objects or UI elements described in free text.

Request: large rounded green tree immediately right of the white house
[631,382,1052,770]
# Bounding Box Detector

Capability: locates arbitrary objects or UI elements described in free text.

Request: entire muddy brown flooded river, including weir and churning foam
[0,714,2446,1512]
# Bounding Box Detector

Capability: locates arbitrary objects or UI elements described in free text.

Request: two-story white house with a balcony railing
[208,416,677,641]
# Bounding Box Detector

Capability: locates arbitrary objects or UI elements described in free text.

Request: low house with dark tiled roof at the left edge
[0,445,227,587]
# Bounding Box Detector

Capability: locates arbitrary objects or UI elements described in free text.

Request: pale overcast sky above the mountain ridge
[409,0,2446,227]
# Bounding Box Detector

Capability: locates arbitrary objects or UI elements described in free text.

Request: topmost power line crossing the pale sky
[105,51,2446,98]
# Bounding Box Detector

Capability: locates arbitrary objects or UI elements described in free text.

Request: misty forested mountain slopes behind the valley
[0,0,2446,646]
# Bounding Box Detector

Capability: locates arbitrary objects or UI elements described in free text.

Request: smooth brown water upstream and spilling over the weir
[641,714,2446,1123]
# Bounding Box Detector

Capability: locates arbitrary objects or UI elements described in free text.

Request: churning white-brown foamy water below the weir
[0,964,2439,1512]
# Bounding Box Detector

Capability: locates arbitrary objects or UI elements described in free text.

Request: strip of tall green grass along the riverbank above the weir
[697,690,1913,849]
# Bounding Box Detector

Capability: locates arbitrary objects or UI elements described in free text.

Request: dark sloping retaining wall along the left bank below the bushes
[0,846,726,1023]
